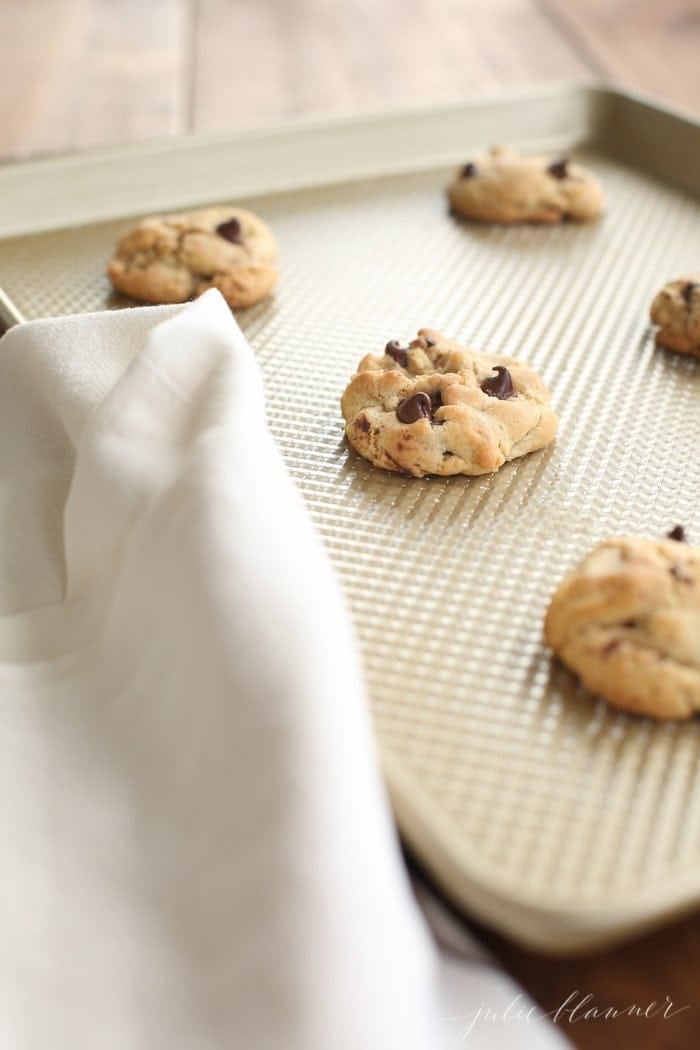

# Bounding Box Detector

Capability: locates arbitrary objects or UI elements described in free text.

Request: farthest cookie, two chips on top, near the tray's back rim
[447,146,602,223]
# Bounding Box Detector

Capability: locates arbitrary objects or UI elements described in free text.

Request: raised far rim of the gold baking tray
[0,81,700,239]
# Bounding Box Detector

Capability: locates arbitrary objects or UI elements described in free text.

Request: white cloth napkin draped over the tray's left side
[0,292,570,1050]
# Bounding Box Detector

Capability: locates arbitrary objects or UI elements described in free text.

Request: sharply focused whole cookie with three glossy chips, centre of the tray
[341,329,558,478]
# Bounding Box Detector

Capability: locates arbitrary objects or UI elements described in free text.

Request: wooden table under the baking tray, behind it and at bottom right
[0,0,700,1050]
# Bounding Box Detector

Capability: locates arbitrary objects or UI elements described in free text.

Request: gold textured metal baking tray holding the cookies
[0,86,700,951]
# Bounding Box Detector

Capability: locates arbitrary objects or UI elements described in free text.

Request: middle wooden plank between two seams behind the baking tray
[193,0,590,129]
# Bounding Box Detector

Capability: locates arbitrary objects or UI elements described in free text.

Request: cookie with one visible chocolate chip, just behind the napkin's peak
[107,207,277,308]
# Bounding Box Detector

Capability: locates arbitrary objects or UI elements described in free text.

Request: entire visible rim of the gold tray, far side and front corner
[0,82,700,954]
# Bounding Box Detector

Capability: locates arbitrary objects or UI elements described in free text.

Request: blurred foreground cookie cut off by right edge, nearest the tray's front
[545,528,700,718]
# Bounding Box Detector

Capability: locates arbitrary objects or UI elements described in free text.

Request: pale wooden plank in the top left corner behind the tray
[0,0,190,155]
